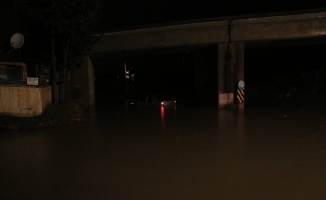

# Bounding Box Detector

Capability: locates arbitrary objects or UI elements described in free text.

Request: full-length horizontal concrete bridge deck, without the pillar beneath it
[89,12,326,55]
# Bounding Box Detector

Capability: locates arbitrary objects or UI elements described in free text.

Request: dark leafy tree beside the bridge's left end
[15,0,101,103]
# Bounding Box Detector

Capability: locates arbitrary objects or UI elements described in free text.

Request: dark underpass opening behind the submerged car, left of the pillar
[92,45,217,106]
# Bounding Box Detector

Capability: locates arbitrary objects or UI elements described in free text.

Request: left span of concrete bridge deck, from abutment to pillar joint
[89,20,229,54]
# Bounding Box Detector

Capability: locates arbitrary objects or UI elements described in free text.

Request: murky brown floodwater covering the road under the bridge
[0,104,326,200]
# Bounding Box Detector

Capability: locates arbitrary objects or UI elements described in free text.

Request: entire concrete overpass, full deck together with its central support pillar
[89,9,326,107]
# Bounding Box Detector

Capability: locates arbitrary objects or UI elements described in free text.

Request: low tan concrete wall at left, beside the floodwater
[0,86,52,117]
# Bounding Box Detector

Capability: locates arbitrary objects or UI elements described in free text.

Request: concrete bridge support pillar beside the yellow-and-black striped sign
[217,43,244,108]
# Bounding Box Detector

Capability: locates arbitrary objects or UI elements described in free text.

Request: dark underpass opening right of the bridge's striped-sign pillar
[245,40,326,107]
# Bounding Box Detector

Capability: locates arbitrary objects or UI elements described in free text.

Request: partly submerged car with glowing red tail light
[137,95,177,108]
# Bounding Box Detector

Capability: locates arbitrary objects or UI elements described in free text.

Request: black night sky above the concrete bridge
[98,0,326,31]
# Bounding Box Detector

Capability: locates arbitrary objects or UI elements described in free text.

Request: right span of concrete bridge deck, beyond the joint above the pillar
[230,12,326,42]
